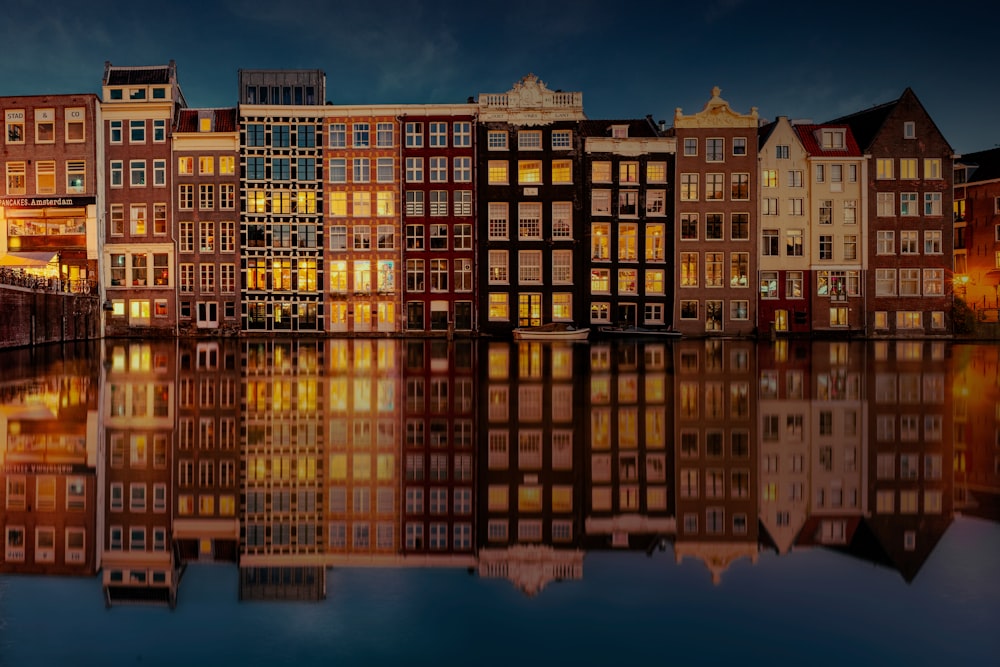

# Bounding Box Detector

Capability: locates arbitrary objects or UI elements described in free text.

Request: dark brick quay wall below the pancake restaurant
[0,285,101,348]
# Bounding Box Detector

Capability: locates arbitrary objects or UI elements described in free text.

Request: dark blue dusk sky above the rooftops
[0,0,1000,153]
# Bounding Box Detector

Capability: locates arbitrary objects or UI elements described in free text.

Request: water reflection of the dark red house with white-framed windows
[401,338,476,567]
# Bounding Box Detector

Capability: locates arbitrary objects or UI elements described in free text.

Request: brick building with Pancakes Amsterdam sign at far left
[0,95,104,292]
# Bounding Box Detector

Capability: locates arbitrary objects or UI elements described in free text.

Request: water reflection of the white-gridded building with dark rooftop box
[239,339,326,599]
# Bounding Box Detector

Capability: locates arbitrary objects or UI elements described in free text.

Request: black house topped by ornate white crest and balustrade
[478,74,589,334]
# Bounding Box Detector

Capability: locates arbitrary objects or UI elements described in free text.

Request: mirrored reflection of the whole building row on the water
[0,338,1000,605]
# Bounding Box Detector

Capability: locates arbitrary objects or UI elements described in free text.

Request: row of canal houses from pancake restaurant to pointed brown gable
[0,62,955,336]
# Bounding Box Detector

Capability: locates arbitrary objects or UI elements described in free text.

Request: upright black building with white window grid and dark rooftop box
[239,70,326,333]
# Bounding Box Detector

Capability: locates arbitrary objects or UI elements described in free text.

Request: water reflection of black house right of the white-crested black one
[585,341,676,548]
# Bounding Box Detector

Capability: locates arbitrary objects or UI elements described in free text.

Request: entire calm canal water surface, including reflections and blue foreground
[0,339,1000,666]
